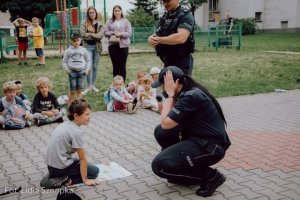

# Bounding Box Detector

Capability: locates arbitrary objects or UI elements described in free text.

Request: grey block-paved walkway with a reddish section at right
[0,90,300,200]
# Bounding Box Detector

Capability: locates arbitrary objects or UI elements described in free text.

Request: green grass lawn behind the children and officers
[0,33,300,111]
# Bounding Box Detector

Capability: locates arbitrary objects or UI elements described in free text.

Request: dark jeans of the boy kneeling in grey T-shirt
[48,159,99,184]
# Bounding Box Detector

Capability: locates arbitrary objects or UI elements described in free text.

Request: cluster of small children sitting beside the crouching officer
[104,67,161,114]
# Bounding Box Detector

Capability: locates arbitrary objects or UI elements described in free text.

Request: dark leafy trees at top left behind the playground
[0,0,78,26]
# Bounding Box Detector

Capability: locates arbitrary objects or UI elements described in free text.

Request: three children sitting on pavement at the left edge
[0,77,66,129]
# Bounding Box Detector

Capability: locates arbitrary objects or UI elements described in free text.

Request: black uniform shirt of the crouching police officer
[168,88,230,149]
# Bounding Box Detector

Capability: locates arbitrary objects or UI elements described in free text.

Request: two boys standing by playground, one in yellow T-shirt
[13,17,45,66]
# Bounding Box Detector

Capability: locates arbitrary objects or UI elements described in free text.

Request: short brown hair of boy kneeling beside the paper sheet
[67,98,91,121]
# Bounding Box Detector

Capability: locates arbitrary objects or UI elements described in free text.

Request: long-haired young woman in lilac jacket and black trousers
[104,5,132,81]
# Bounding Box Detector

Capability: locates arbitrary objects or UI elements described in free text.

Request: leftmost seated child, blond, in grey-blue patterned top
[0,81,32,129]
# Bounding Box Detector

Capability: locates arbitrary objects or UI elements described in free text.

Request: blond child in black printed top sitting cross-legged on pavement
[32,77,65,126]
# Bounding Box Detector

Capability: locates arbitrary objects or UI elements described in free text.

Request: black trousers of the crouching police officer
[152,125,225,185]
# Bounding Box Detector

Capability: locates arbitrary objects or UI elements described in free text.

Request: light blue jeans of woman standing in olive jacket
[86,44,100,86]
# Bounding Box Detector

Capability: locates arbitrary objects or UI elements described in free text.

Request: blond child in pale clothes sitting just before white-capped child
[137,74,158,111]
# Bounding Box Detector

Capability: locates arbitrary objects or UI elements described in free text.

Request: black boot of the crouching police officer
[196,169,226,197]
